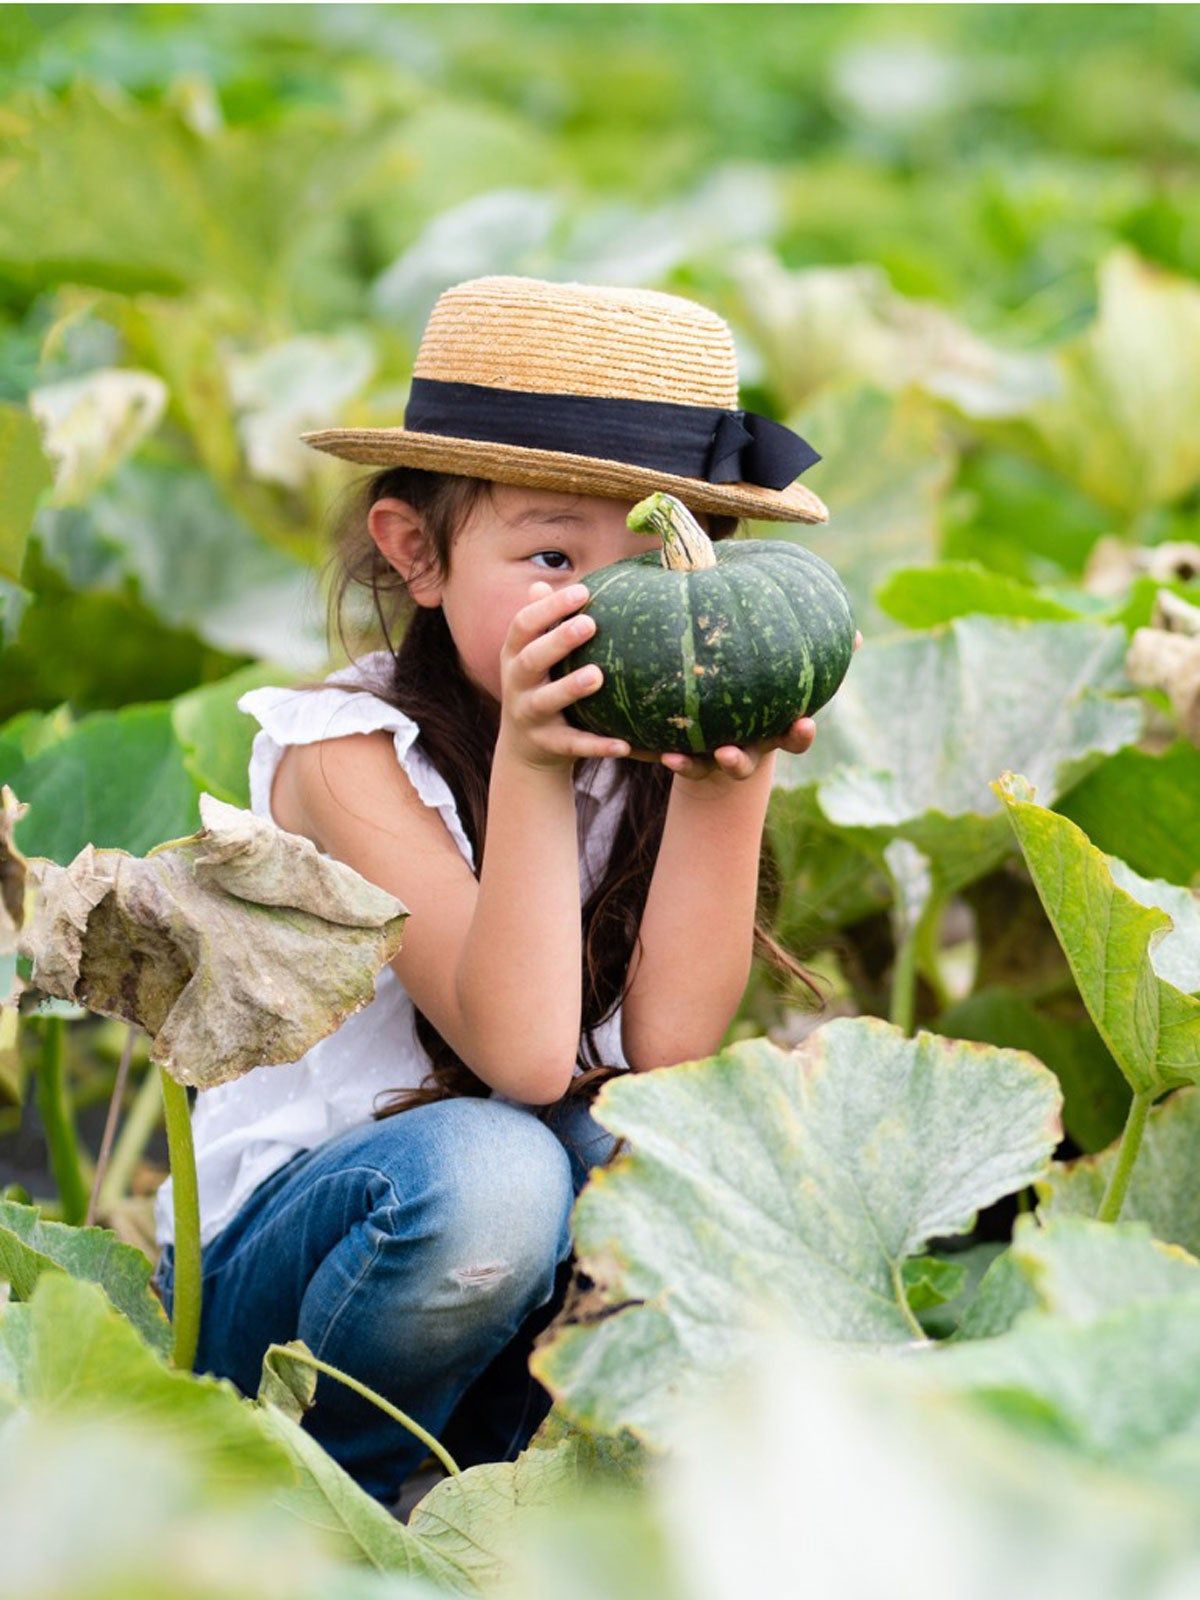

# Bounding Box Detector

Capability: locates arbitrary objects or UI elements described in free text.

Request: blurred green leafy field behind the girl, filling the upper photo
[0,5,1200,859]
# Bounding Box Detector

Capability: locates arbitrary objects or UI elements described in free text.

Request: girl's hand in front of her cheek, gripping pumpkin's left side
[499,582,629,773]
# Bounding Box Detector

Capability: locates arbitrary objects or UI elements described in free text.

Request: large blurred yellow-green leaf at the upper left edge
[0,74,374,307]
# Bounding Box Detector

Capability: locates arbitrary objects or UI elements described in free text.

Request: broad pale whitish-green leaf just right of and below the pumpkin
[776,616,1142,893]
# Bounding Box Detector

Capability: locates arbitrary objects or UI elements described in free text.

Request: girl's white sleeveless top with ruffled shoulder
[155,650,629,1245]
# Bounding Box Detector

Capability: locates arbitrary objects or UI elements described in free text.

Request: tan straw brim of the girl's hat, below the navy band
[299,427,829,523]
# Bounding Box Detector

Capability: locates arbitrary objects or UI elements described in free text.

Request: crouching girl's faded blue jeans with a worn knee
[155,1098,616,1504]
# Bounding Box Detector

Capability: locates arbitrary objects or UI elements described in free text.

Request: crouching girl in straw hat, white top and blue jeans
[157,277,851,1502]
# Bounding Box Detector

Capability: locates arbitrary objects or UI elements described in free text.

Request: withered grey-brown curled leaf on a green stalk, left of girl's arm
[19,794,408,1088]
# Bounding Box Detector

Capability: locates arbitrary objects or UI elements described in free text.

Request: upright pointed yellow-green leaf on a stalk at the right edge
[995,773,1200,1094]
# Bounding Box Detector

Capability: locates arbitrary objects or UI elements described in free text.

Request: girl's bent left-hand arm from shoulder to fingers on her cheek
[286,582,629,1106]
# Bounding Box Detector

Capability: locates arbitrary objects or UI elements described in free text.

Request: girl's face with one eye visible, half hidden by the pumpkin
[371,483,694,704]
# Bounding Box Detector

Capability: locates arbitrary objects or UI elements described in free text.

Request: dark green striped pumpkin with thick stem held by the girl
[550,494,854,754]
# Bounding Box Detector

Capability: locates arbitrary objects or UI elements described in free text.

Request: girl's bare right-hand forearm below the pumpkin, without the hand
[621,750,774,1072]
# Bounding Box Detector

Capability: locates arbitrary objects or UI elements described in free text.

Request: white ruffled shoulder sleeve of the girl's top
[237,658,475,869]
